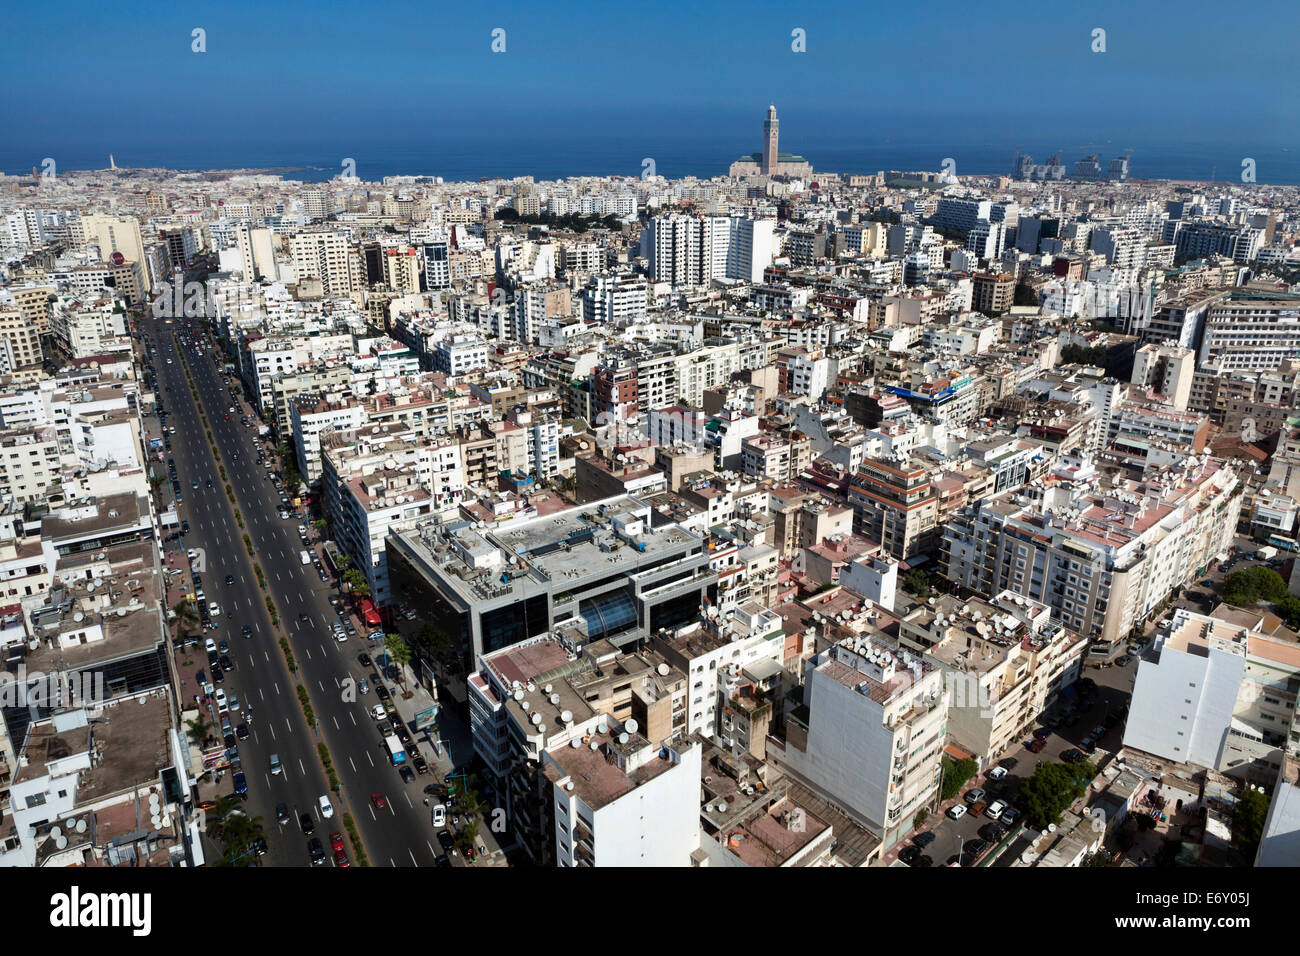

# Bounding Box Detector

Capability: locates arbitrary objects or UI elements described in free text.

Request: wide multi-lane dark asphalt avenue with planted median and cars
[140,319,447,866]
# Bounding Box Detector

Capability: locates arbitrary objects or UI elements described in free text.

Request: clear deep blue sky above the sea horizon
[0,0,1300,157]
